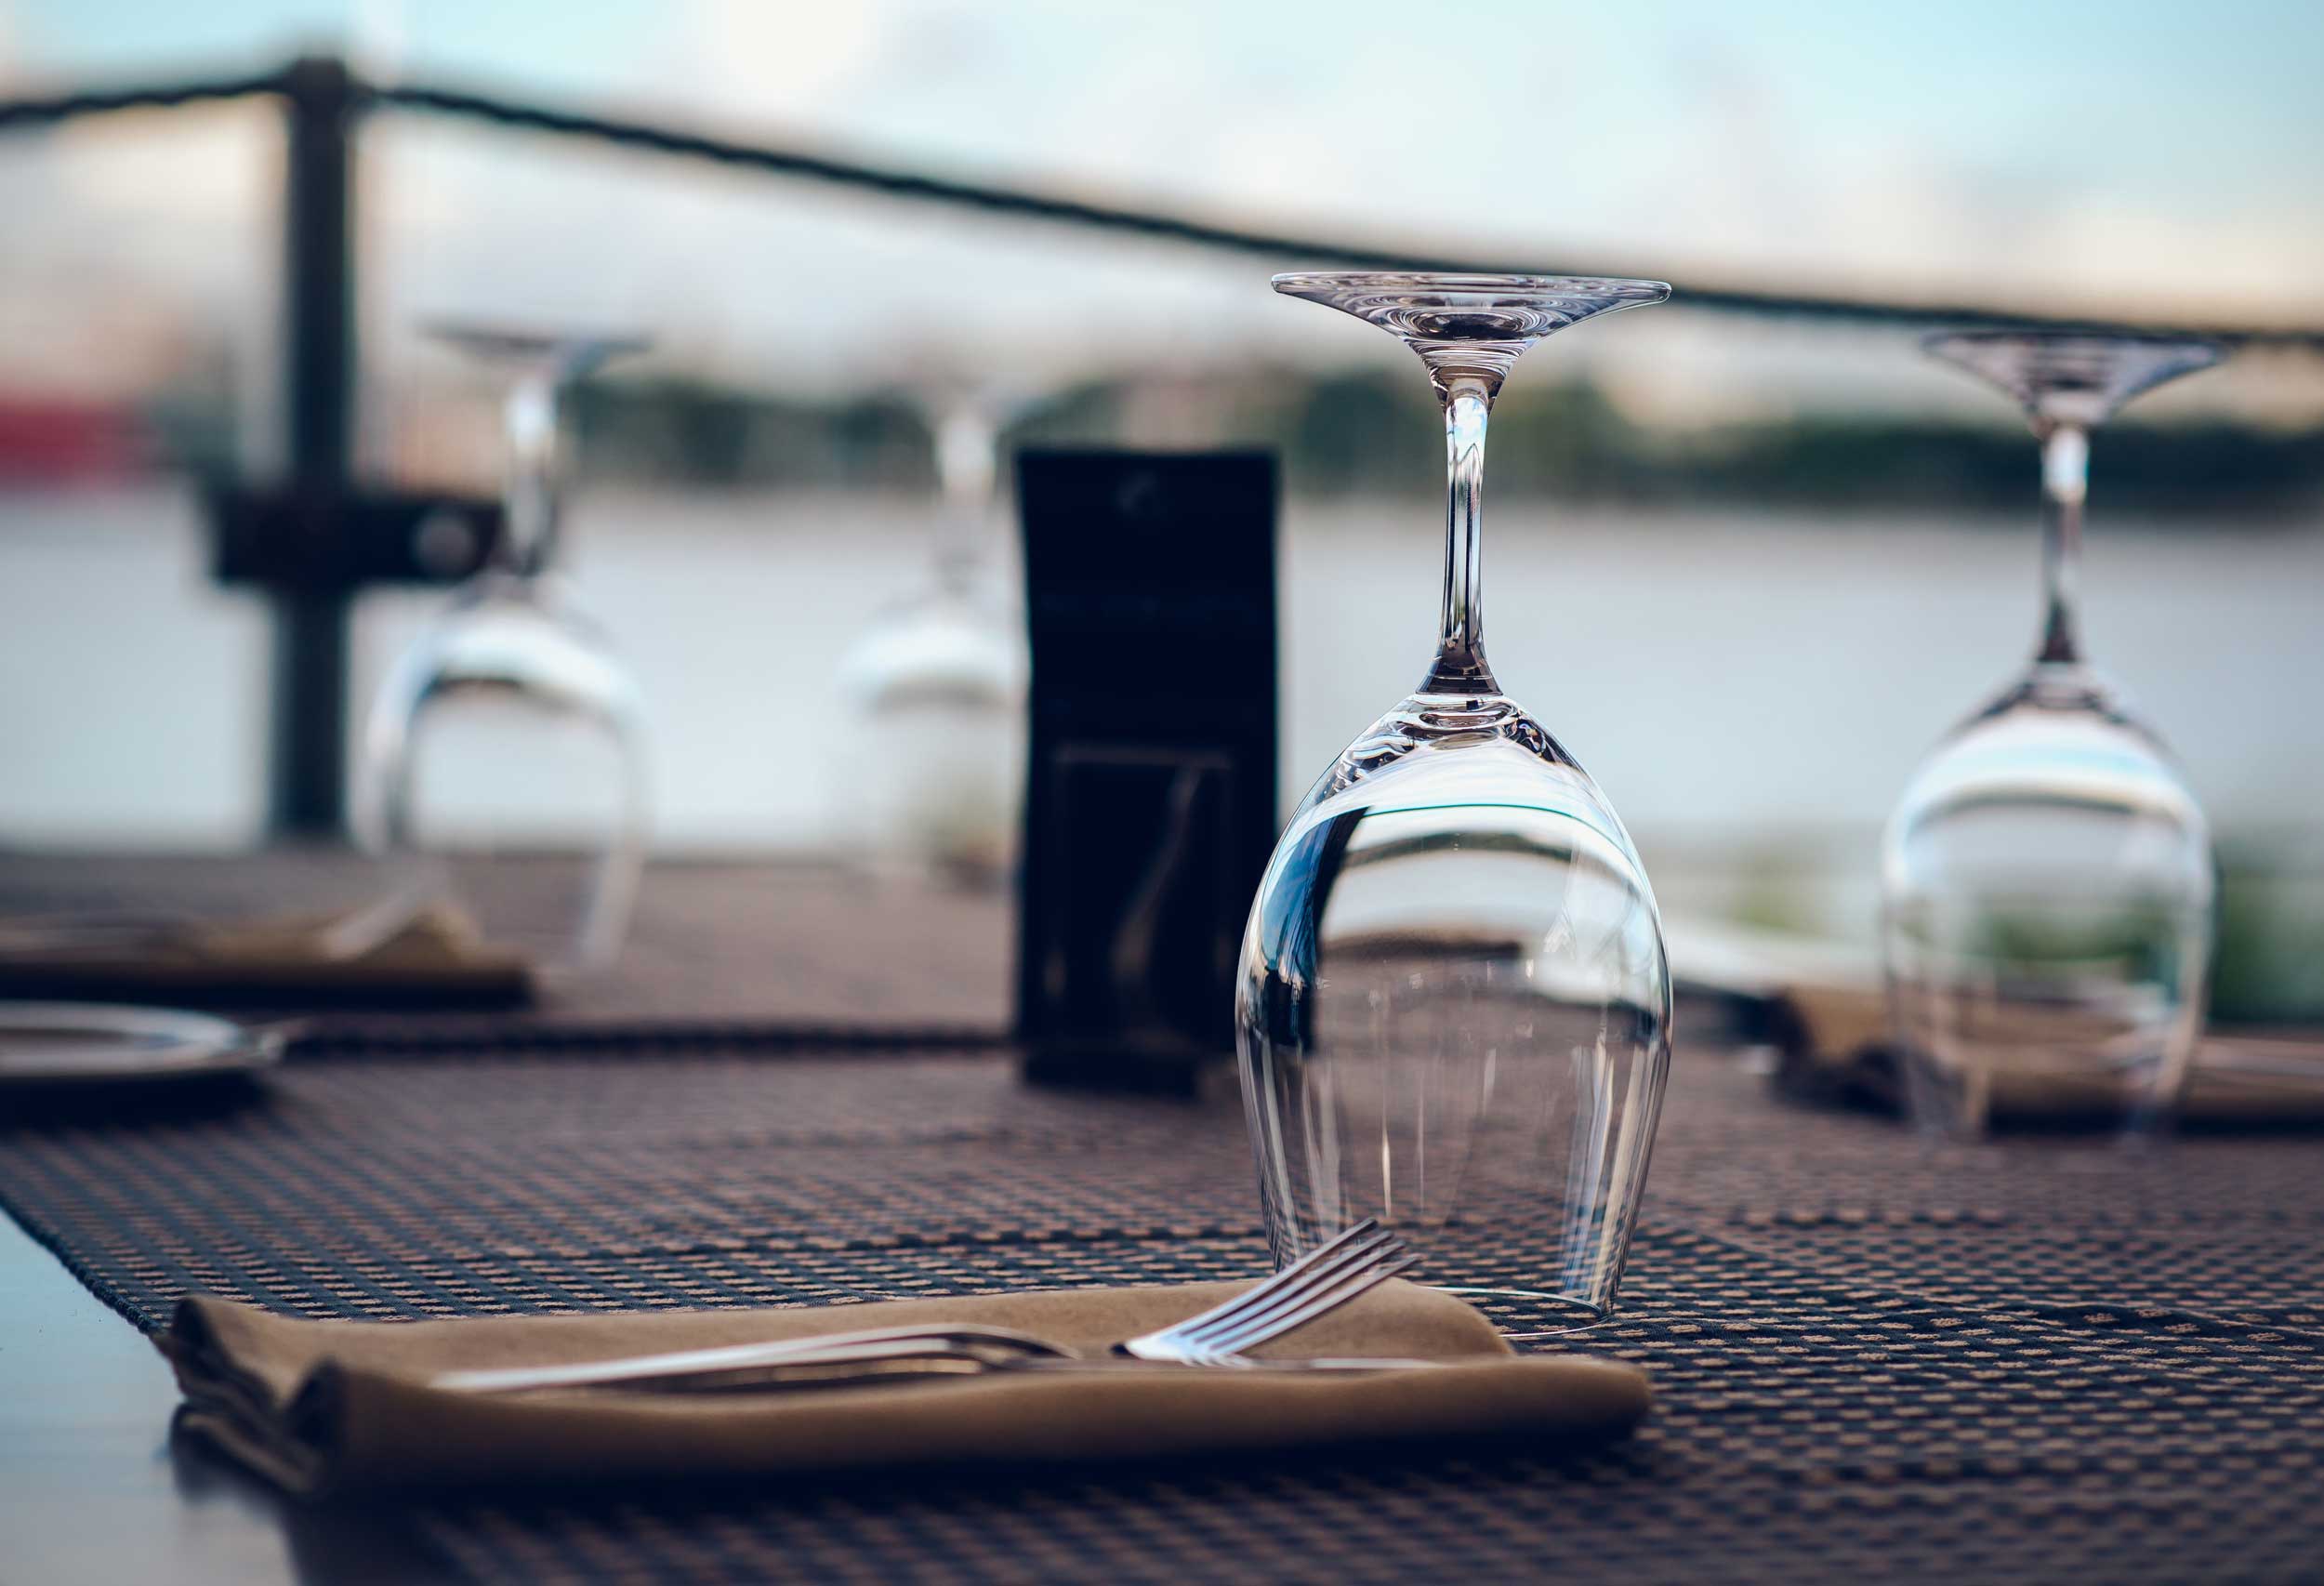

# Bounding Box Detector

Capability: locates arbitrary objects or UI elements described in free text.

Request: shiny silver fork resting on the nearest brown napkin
[430,1219,1416,1393]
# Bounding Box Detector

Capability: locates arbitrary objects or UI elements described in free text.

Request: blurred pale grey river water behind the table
[0,486,2324,917]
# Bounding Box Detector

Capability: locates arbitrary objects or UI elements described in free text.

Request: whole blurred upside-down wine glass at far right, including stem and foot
[1881,333,2220,1135]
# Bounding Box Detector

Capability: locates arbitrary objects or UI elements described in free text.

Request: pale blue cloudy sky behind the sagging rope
[0,0,2324,416]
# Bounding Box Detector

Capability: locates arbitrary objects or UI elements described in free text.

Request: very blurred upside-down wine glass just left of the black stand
[835,384,1027,886]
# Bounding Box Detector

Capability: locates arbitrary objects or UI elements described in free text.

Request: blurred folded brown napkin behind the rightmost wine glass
[1771,982,2324,1123]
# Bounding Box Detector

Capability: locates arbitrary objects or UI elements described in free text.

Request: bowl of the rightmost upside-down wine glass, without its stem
[1882,688,2215,1132]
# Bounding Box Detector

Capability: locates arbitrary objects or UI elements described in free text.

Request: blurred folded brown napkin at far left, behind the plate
[0,905,533,1005]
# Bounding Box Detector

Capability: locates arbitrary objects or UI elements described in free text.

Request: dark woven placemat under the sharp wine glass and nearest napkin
[0,1053,2324,1581]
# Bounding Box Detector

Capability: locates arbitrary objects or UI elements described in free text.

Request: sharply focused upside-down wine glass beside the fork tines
[1236,274,1671,1337]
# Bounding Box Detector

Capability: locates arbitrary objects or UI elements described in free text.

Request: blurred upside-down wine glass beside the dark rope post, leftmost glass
[356,325,646,972]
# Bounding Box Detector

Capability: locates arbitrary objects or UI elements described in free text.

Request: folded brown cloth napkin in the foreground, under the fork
[161,1279,1648,1493]
